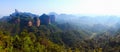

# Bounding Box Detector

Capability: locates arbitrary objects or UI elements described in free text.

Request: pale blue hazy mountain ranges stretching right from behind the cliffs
[47,12,120,32]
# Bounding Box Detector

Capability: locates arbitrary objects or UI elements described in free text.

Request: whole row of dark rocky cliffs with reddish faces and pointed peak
[5,10,55,27]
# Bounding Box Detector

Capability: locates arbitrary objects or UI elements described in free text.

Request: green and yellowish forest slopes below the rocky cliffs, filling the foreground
[0,22,120,52]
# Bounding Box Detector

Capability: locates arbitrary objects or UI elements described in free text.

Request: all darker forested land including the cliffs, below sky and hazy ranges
[0,10,120,52]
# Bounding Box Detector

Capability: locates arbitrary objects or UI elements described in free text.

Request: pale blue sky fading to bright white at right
[0,0,120,16]
